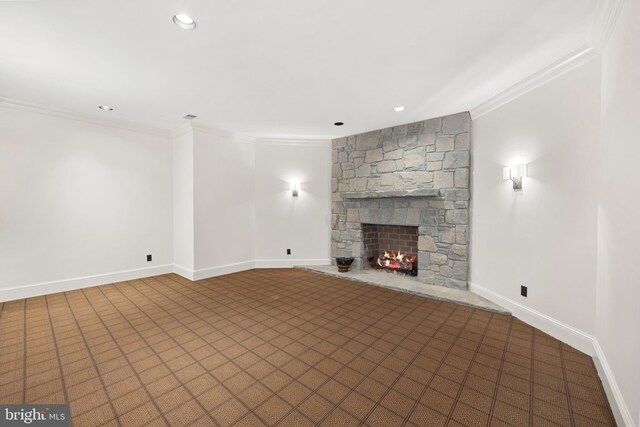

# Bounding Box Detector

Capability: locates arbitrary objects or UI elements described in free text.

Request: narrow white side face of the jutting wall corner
[172,126,195,276]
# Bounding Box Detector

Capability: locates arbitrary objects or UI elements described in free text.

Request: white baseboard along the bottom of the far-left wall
[0,264,173,302]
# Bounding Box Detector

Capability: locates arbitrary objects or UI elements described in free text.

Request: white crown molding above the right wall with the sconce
[470,46,597,120]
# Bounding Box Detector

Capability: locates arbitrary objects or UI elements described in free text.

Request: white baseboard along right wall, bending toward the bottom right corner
[468,282,636,427]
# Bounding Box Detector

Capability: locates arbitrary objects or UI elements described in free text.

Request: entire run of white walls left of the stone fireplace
[0,110,331,301]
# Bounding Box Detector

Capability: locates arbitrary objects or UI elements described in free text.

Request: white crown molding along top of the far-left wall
[0,97,169,138]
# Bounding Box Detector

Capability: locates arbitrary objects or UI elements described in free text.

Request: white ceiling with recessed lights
[0,0,598,137]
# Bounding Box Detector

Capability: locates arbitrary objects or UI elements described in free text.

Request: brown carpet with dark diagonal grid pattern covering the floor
[0,269,615,427]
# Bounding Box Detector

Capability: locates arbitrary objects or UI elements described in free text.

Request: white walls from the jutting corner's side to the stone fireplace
[173,131,331,279]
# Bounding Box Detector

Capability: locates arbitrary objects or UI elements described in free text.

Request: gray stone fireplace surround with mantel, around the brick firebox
[331,112,471,289]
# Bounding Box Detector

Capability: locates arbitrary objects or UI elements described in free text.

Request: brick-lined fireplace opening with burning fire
[362,224,418,276]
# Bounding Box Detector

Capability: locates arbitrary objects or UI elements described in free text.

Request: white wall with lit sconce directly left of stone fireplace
[254,140,331,267]
